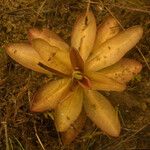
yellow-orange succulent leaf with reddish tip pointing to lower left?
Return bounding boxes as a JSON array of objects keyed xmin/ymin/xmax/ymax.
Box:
[{"xmin": 30, "ymin": 78, "xmax": 70, "ymax": 112}]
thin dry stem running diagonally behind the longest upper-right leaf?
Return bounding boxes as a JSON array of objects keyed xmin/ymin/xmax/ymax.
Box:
[{"xmin": 100, "ymin": 1, "xmax": 150, "ymax": 70}]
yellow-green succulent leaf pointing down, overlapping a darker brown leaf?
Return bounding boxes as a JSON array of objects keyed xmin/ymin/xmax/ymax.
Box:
[{"xmin": 54, "ymin": 87, "xmax": 83, "ymax": 132}]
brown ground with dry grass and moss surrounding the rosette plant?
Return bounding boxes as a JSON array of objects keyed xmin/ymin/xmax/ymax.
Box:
[{"xmin": 0, "ymin": 0, "xmax": 150, "ymax": 150}]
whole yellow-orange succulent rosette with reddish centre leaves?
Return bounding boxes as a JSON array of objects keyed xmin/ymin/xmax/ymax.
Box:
[{"xmin": 6, "ymin": 11, "xmax": 143, "ymax": 142}]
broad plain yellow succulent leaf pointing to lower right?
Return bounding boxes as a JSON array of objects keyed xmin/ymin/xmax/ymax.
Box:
[{"xmin": 84, "ymin": 90, "xmax": 120, "ymax": 137}]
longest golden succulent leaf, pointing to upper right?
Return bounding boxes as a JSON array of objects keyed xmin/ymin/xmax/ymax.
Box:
[{"xmin": 86, "ymin": 26, "xmax": 143, "ymax": 71}]
